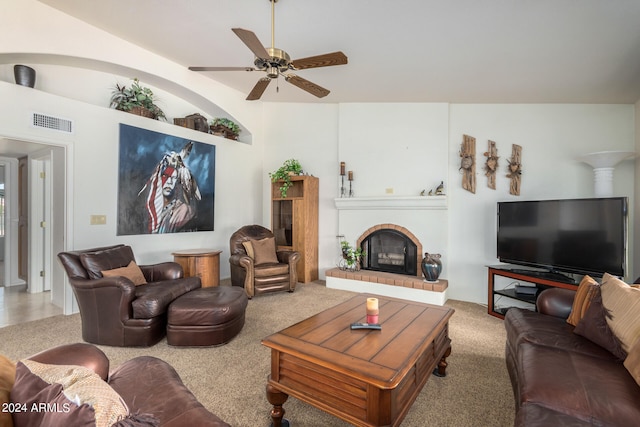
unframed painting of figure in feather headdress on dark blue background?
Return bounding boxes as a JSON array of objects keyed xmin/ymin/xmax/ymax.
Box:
[{"xmin": 118, "ymin": 124, "xmax": 216, "ymax": 236}]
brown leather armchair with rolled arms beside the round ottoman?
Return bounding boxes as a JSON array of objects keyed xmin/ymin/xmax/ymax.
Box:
[{"xmin": 58, "ymin": 245, "xmax": 201, "ymax": 347}]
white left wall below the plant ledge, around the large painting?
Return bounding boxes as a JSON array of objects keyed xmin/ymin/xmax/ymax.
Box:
[{"xmin": 0, "ymin": 82, "xmax": 263, "ymax": 314}]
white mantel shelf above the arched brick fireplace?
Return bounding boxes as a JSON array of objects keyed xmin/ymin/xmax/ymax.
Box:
[{"xmin": 334, "ymin": 196, "xmax": 447, "ymax": 210}]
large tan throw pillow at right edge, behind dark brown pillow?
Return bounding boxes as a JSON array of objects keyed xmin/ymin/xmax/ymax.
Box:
[{"xmin": 600, "ymin": 274, "xmax": 640, "ymax": 353}]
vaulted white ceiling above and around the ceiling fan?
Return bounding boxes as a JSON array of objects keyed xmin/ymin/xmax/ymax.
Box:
[{"xmin": 40, "ymin": 0, "xmax": 640, "ymax": 103}]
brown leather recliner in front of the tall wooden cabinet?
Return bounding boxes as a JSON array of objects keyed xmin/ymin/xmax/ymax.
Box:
[{"xmin": 229, "ymin": 225, "xmax": 300, "ymax": 298}]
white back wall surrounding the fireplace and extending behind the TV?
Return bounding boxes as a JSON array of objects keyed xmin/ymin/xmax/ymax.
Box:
[{"xmin": 265, "ymin": 104, "xmax": 634, "ymax": 303}]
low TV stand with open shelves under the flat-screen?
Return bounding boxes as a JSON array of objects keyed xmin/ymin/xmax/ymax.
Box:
[{"xmin": 487, "ymin": 265, "xmax": 578, "ymax": 319}]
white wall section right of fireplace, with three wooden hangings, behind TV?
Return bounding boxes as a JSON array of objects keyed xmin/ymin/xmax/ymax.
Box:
[{"xmin": 449, "ymin": 104, "xmax": 634, "ymax": 302}]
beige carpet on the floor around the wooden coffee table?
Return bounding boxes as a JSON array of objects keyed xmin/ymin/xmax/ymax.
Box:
[{"xmin": 0, "ymin": 283, "xmax": 514, "ymax": 427}]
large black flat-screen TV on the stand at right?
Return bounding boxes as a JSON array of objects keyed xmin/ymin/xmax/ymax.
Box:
[{"xmin": 497, "ymin": 197, "xmax": 628, "ymax": 277}]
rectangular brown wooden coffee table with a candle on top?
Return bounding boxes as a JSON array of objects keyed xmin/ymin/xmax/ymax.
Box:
[{"xmin": 262, "ymin": 294, "xmax": 454, "ymax": 427}]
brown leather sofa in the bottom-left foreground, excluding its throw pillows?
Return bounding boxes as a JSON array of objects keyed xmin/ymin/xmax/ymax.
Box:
[{"xmin": 12, "ymin": 343, "xmax": 229, "ymax": 427}]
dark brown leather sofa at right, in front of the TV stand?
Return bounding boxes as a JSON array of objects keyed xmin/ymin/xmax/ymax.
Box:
[{"xmin": 504, "ymin": 288, "xmax": 640, "ymax": 427}]
